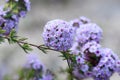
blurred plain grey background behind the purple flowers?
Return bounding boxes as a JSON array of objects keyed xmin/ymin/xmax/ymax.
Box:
[{"xmin": 0, "ymin": 0, "xmax": 120, "ymax": 80}]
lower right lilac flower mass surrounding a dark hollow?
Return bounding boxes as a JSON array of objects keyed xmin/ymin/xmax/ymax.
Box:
[{"xmin": 73, "ymin": 41, "xmax": 120, "ymax": 80}]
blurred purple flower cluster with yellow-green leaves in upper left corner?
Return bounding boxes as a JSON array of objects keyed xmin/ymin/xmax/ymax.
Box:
[{"xmin": 0, "ymin": 0, "xmax": 30, "ymax": 36}]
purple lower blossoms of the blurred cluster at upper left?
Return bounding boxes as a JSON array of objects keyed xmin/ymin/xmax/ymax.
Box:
[{"xmin": 0, "ymin": 7, "xmax": 19, "ymax": 35}]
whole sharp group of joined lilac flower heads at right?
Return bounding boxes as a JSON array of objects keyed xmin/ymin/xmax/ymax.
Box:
[{"xmin": 43, "ymin": 17, "xmax": 120, "ymax": 80}]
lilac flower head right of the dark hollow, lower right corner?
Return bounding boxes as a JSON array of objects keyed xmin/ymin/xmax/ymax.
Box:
[{"xmin": 93, "ymin": 48, "xmax": 118, "ymax": 80}]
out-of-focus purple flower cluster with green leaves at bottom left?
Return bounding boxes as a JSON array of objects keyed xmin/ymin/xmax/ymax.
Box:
[{"xmin": 18, "ymin": 53, "xmax": 53, "ymax": 80}]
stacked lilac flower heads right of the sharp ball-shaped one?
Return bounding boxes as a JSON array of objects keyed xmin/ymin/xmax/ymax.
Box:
[{"xmin": 70, "ymin": 17, "xmax": 120, "ymax": 80}]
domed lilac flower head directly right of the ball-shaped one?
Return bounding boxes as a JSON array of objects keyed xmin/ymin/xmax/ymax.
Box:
[{"xmin": 75, "ymin": 23, "xmax": 102, "ymax": 45}]
